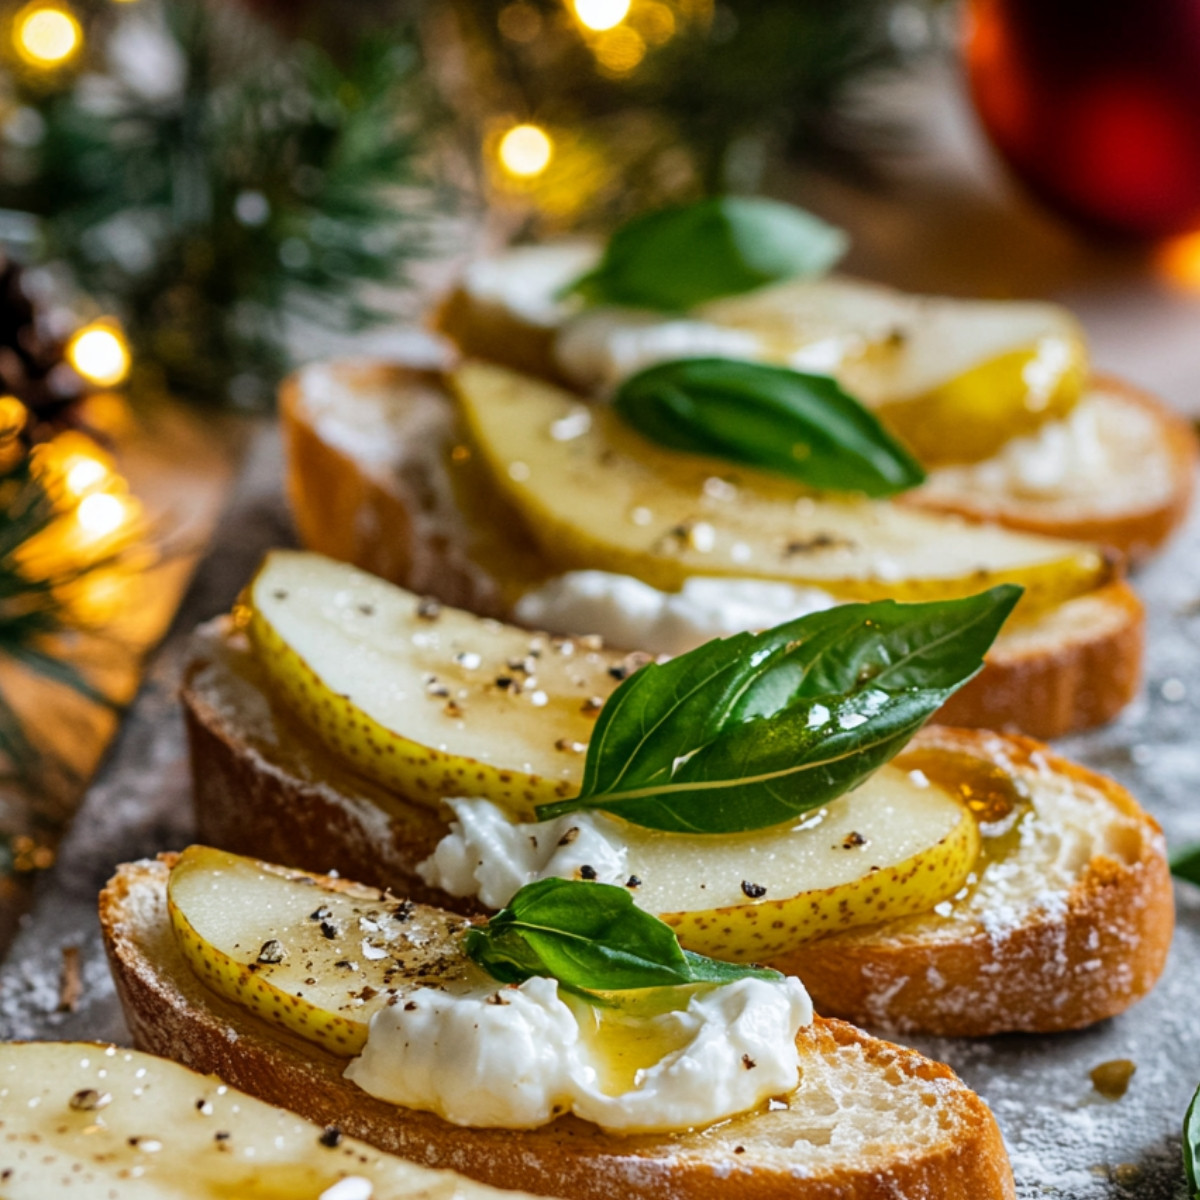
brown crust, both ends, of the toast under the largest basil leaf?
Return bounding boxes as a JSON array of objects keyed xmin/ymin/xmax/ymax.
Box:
[{"xmin": 182, "ymin": 633, "xmax": 1174, "ymax": 1036}]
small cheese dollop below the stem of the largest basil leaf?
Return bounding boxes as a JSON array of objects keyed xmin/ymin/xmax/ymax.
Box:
[{"xmin": 416, "ymin": 798, "xmax": 629, "ymax": 908}]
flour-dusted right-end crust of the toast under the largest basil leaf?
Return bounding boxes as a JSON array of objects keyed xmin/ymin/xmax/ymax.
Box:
[{"xmin": 774, "ymin": 727, "xmax": 1175, "ymax": 1037}]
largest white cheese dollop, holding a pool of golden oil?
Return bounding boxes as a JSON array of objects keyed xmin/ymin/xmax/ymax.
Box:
[{"xmin": 346, "ymin": 972, "xmax": 812, "ymax": 1133}]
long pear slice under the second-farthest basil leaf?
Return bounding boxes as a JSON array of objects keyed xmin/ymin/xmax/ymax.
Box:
[{"xmin": 454, "ymin": 364, "xmax": 1110, "ymax": 613}]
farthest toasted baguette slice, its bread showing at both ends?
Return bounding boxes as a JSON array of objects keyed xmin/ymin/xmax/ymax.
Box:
[{"xmin": 432, "ymin": 262, "xmax": 1198, "ymax": 563}]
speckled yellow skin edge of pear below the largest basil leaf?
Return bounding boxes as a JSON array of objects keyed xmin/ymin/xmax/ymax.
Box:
[{"xmin": 659, "ymin": 808, "xmax": 980, "ymax": 962}]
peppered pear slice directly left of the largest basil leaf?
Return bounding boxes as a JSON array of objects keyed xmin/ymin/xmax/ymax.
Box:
[{"xmin": 239, "ymin": 551, "xmax": 620, "ymax": 816}]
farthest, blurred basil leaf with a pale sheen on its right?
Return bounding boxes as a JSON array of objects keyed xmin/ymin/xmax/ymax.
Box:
[{"xmin": 566, "ymin": 196, "xmax": 847, "ymax": 312}]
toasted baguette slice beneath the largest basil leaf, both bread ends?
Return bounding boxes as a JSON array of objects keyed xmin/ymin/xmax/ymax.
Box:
[{"xmin": 184, "ymin": 623, "xmax": 1174, "ymax": 1036}]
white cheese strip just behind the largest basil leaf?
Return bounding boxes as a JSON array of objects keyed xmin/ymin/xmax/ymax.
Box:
[{"xmin": 514, "ymin": 571, "xmax": 838, "ymax": 654}]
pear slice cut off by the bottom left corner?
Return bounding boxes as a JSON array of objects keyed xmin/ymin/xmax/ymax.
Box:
[{"xmin": 0, "ymin": 1042, "xmax": 544, "ymax": 1200}]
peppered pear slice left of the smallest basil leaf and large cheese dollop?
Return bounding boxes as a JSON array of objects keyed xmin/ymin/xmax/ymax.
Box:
[{"xmin": 167, "ymin": 846, "xmax": 478, "ymax": 1057}]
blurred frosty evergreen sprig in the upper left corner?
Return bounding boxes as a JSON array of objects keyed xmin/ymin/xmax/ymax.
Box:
[{"xmin": 0, "ymin": 0, "xmax": 431, "ymax": 407}]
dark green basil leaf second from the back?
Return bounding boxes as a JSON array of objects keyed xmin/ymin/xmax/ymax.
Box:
[{"xmin": 613, "ymin": 359, "xmax": 925, "ymax": 496}]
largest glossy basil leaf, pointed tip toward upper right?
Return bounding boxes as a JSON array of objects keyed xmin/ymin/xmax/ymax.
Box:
[{"xmin": 538, "ymin": 584, "xmax": 1021, "ymax": 834}]
